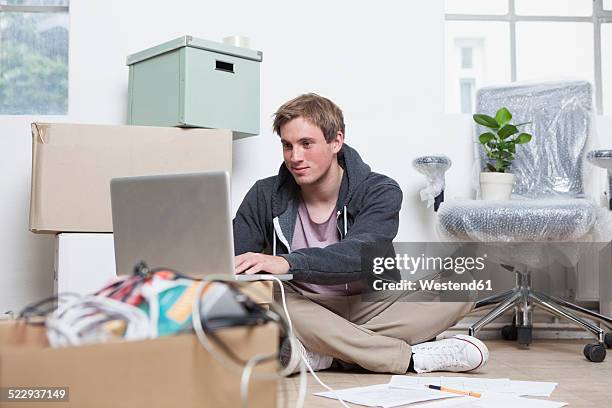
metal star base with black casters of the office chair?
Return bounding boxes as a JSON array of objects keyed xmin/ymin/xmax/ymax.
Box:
[{"xmin": 469, "ymin": 265, "xmax": 612, "ymax": 362}]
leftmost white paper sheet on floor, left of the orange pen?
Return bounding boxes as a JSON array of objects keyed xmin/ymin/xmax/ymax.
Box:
[{"xmin": 315, "ymin": 384, "xmax": 461, "ymax": 408}]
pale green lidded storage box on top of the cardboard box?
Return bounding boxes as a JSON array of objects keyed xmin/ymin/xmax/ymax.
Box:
[{"xmin": 127, "ymin": 35, "xmax": 263, "ymax": 139}]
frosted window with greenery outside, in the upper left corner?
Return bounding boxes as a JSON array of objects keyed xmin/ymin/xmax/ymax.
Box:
[{"xmin": 0, "ymin": 0, "xmax": 68, "ymax": 115}]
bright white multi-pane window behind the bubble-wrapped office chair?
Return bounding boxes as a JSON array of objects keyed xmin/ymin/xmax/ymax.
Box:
[{"xmin": 445, "ymin": 0, "xmax": 612, "ymax": 114}]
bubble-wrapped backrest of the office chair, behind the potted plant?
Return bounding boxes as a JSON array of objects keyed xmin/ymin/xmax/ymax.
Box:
[{"xmin": 475, "ymin": 81, "xmax": 593, "ymax": 198}]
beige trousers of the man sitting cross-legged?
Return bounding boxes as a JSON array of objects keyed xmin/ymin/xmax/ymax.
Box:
[{"xmin": 274, "ymin": 284, "xmax": 474, "ymax": 374}]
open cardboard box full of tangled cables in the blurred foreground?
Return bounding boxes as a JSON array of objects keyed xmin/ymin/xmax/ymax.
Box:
[{"xmin": 0, "ymin": 266, "xmax": 285, "ymax": 408}]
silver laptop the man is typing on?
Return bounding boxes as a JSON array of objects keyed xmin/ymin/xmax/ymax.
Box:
[{"xmin": 111, "ymin": 172, "xmax": 293, "ymax": 281}]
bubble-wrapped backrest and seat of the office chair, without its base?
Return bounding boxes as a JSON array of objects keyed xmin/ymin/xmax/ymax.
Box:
[{"xmin": 437, "ymin": 81, "xmax": 612, "ymax": 267}]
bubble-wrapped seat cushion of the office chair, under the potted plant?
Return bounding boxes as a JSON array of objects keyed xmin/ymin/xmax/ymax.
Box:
[{"xmin": 438, "ymin": 199, "xmax": 612, "ymax": 269}]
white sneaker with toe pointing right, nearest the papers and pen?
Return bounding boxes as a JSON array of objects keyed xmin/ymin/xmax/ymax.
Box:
[{"xmin": 412, "ymin": 334, "xmax": 489, "ymax": 373}]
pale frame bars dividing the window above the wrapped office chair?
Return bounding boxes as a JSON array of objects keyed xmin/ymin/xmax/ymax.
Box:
[{"xmin": 445, "ymin": 0, "xmax": 612, "ymax": 115}]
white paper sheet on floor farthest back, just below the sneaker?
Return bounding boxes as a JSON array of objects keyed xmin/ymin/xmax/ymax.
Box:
[{"xmin": 389, "ymin": 375, "xmax": 557, "ymax": 397}]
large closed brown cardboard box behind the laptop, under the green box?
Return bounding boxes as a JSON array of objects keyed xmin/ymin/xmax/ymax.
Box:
[{"xmin": 30, "ymin": 123, "xmax": 232, "ymax": 232}]
